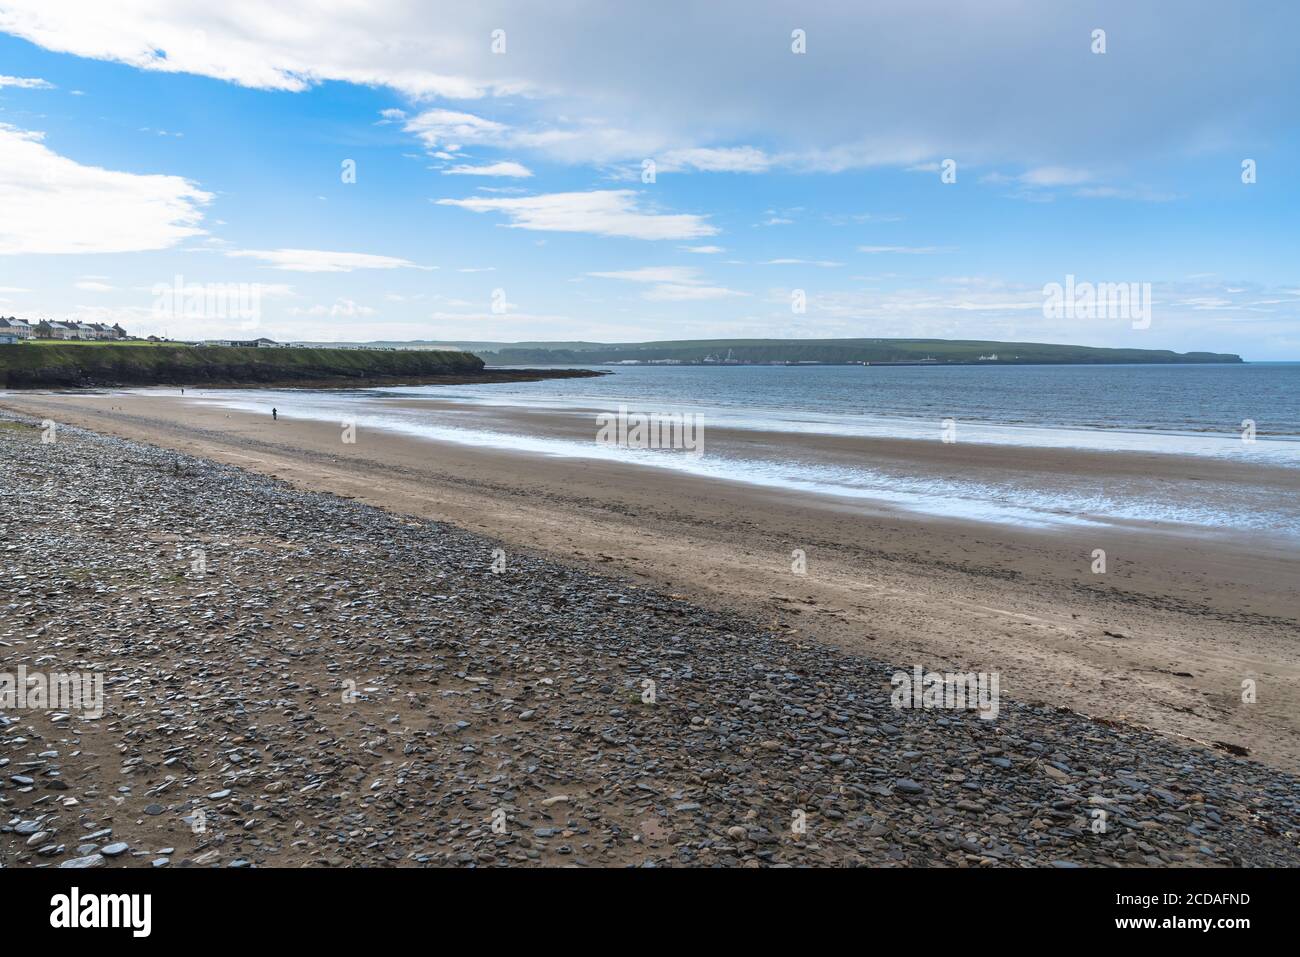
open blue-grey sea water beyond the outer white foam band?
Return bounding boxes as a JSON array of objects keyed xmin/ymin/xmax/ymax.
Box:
[{"xmin": 449, "ymin": 363, "xmax": 1300, "ymax": 438}]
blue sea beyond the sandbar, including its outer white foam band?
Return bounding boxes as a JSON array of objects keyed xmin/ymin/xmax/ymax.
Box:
[{"xmin": 386, "ymin": 363, "xmax": 1300, "ymax": 467}]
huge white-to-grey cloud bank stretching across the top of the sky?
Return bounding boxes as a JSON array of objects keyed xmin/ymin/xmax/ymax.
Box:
[{"xmin": 0, "ymin": 0, "xmax": 1297, "ymax": 172}]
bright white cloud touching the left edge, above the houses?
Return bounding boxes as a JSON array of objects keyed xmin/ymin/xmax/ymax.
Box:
[{"xmin": 0, "ymin": 124, "xmax": 212, "ymax": 255}]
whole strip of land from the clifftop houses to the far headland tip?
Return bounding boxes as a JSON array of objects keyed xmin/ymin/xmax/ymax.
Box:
[{"xmin": 0, "ymin": 327, "xmax": 1242, "ymax": 389}]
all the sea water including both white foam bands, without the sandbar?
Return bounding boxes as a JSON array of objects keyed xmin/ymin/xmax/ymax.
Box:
[{"xmin": 172, "ymin": 363, "xmax": 1300, "ymax": 540}]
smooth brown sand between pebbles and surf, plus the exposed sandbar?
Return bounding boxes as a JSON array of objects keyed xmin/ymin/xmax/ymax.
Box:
[{"xmin": 10, "ymin": 391, "xmax": 1300, "ymax": 771}]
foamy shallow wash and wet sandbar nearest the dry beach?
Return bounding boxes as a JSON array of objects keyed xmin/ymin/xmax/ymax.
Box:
[{"xmin": 178, "ymin": 390, "xmax": 1300, "ymax": 538}]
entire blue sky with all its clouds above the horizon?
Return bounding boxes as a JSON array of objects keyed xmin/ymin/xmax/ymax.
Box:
[{"xmin": 0, "ymin": 0, "xmax": 1300, "ymax": 360}]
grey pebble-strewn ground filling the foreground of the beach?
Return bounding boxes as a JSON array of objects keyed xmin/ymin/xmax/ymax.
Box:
[{"xmin": 0, "ymin": 416, "xmax": 1300, "ymax": 869}]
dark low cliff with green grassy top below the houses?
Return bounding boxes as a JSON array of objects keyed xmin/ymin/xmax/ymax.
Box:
[{"xmin": 0, "ymin": 343, "xmax": 484, "ymax": 389}]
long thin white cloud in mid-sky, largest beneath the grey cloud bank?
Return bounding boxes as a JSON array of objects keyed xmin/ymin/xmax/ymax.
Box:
[{"xmin": 437, "ymin": 190, "xmax": 718, "ymax": 239}]
